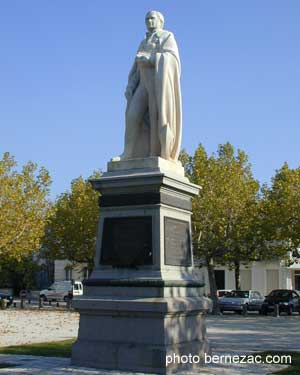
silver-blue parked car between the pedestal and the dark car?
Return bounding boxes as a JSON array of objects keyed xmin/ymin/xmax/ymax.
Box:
[{"xmin": 219, "ymin": 290, "xmax": 264, "ymax": 314}]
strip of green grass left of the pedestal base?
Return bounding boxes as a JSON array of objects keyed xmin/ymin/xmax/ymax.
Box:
[{"xmin": 0, "ymin": 339, "xmax": 75, "ymax": 358}]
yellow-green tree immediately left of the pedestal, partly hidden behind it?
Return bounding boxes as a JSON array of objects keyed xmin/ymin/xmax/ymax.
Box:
[{"xmin": 44, "ymin": 173, "xmax": 100, "ymax": 271}]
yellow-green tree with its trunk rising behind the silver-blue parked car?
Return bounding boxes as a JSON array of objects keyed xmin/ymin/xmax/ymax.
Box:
[{"xmin": 211, "ymin": 143, "xmax": 263, "ymax": 290}]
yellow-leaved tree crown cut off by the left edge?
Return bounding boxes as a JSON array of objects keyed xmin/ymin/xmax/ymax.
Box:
[{"xmin": 0, "ymin": 152, "xmax": 51, "ymax": 261}]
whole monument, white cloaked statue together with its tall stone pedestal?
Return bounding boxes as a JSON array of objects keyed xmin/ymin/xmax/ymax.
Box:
[{"xmin": 72, "ymin": 11, "xmax": 210, "ymax": 374}]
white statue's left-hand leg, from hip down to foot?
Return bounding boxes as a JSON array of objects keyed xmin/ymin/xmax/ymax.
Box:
[{"xmin": 122, "ymin": 84, "xmax": 148, "ymax": 159}]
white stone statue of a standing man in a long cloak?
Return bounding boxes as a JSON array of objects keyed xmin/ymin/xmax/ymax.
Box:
[{"xmin": 121, "ymin": 11, "xmax": 181, "ymax": 161}]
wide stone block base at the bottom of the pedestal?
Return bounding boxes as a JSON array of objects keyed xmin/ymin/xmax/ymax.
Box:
[{"xmin": 72, "ymin": 297, "xmax": 210, "ymax": 374}]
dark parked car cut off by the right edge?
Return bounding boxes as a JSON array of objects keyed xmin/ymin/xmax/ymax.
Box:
[{"xmin": 261, "ymin": 289, "xmax": 300, "ymax": 315}]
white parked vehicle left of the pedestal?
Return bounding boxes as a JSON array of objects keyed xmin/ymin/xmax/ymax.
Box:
[{"xmin": 40, "ymin": 280, "xmax": 83, "ymax": 302}]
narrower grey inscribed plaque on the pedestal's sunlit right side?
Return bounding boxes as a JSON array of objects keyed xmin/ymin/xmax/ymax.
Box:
[{"xmin": 164, "ymin": 217, "xmax": 192, "ymax": 266}]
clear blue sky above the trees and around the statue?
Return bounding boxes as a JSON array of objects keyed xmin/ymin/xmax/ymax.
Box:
[{"xmin": 0, "ymin": 0, "xmax": 300, "ymax": 197}]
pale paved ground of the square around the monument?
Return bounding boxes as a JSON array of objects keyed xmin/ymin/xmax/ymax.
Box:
[{"xmin": 0, "ymin": 311, "xmax": 300, "ymax": 375}]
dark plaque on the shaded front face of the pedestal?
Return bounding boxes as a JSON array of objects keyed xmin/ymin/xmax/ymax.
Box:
[{"xmin": 100, "ymin": 216, "xmax": 152, "ymax": 268}]
